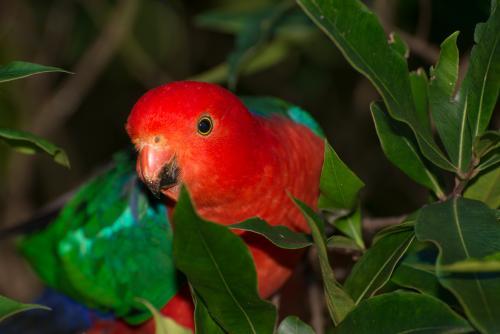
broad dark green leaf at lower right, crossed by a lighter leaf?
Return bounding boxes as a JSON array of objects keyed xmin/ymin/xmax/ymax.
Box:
[{"xmin": 416, "ymin": 198, "xmax": 500, "ymax": 333}]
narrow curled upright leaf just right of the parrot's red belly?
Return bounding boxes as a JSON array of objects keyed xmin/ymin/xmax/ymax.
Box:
[{"xmin": 294, "ymin": 198, "xmax": 354, "ymax": 325}]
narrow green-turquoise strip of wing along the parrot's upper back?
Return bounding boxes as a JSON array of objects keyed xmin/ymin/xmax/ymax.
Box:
[{"xmin": 241, "ymin": 96, "xmax": 325, "ymax": 138}]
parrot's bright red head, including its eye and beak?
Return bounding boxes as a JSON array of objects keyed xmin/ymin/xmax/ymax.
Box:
[{"xmin": 126, "ymin": 81, "xmax": 259, "ymax": 201}]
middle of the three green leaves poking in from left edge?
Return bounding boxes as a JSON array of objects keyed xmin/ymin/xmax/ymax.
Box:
[{"xmin": 0, "ymin": 128, "xmax": 69, "ymax": 168}]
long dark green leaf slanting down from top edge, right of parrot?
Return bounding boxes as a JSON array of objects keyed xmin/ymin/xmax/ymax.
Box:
[{"xmin": 298, "ymin": 0, "xmax": 456, "ymax": 171}]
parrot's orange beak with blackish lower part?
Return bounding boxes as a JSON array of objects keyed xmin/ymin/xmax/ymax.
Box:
[{"xmin": 137, "ymin": 145, "xmax": 179, "ymax": 197}]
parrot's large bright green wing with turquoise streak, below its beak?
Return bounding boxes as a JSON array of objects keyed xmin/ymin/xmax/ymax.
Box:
[{"xmin": 21, "ymin": 153, "xmax": 180, "ymax": 324}]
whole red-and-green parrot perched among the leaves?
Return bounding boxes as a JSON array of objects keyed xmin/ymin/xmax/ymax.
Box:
[{"xmin": 14, "ymin": 81, "xmax": 324, "ymax": 333}]
